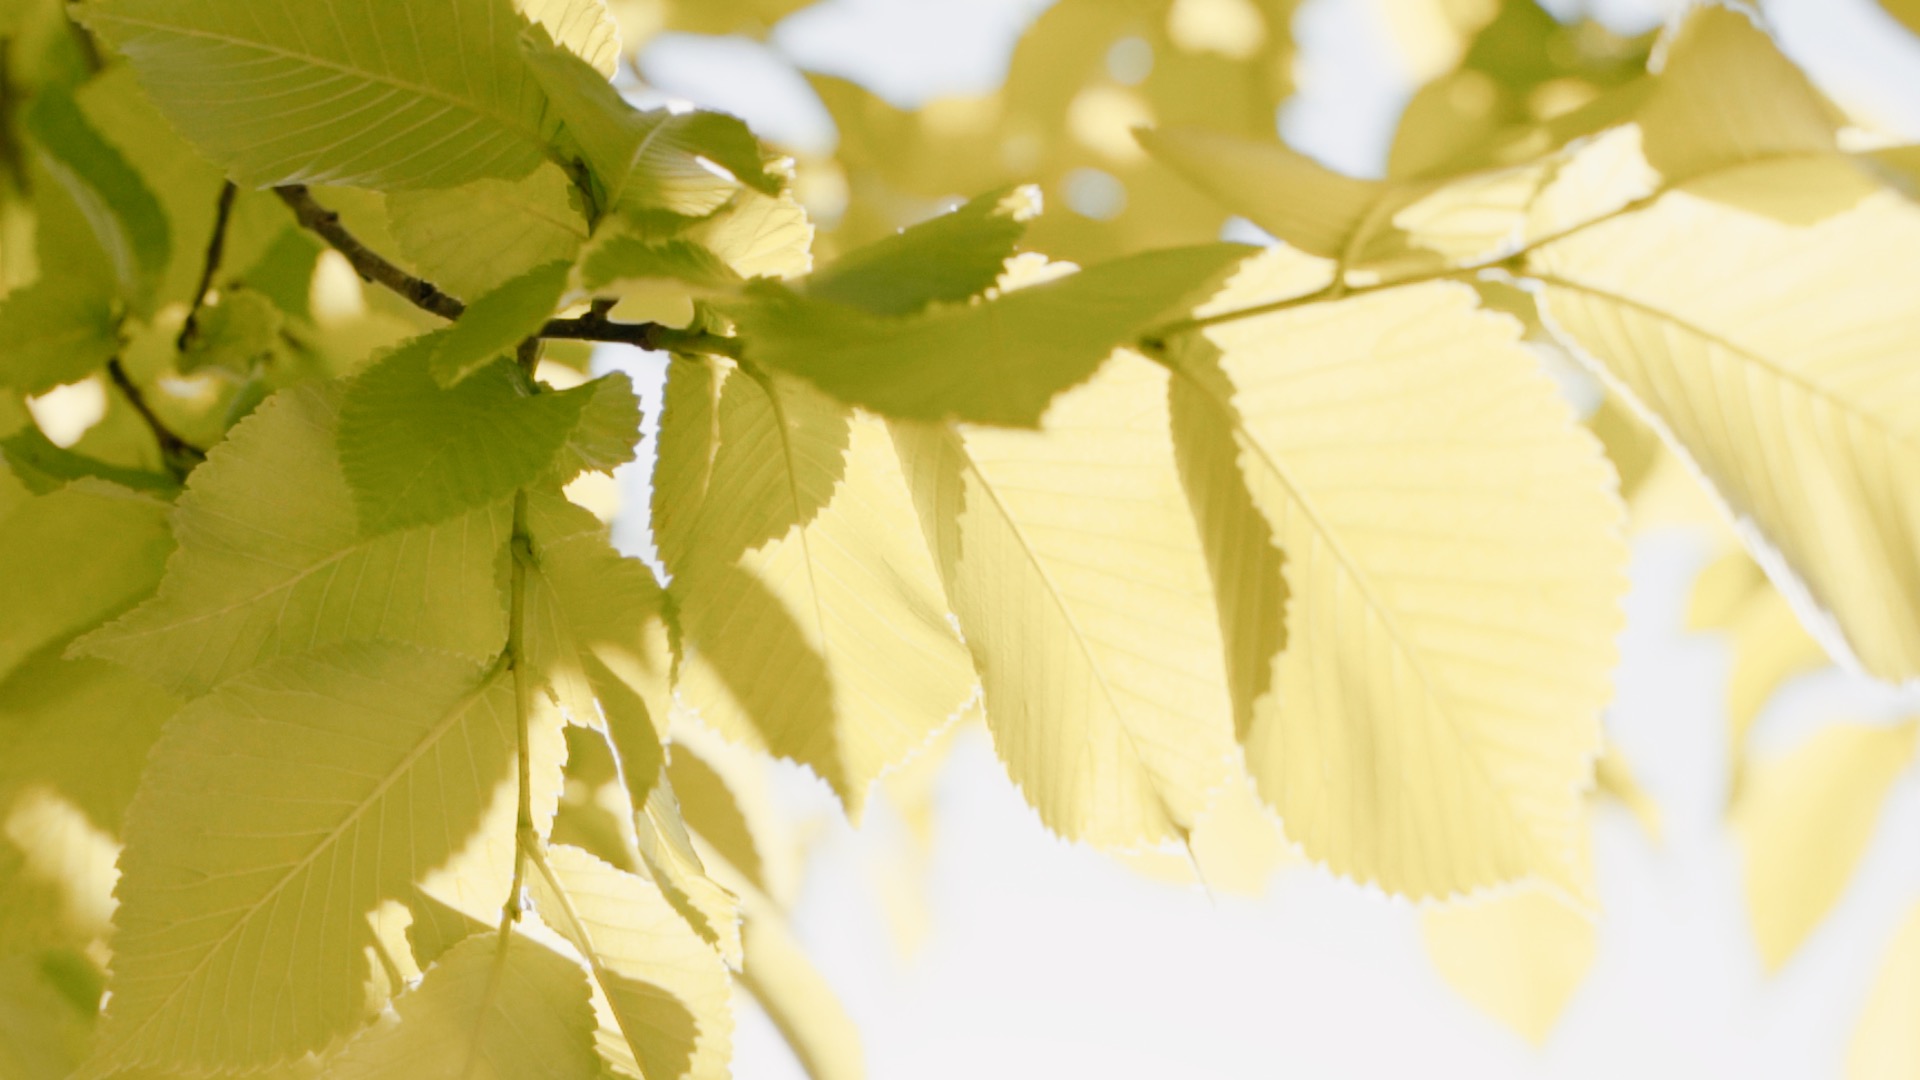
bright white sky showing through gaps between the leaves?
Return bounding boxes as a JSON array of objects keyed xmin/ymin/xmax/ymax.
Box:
[{"xmin": 607, "ymin": 0, "xmax": 1920, "ymax": 1080}]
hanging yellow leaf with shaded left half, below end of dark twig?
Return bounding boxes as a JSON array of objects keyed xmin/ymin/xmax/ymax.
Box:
[{"xmin": 655, "ymin": 361, "xmax": 973, "ymax": 813}]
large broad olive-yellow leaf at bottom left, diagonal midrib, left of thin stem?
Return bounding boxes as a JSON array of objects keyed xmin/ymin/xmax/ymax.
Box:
[{"xmin": 100, "ymin": 642, "xmax": 515, "ymax": 1070}]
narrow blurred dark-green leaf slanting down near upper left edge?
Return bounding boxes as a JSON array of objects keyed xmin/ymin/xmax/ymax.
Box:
[{"xmin": 27, "ymin": 92, "xmax": 173, "ymax": 313}]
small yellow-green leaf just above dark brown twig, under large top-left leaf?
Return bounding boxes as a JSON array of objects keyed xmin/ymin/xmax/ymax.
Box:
[{"xmin": 386, "ymin": 163, "xmax": 588, "ymax": 296}]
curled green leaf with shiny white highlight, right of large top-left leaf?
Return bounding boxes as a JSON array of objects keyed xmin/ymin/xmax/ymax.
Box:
[{"xmin": 526, "ymin": 40, "xmax": 781, "ymax": 217}]
